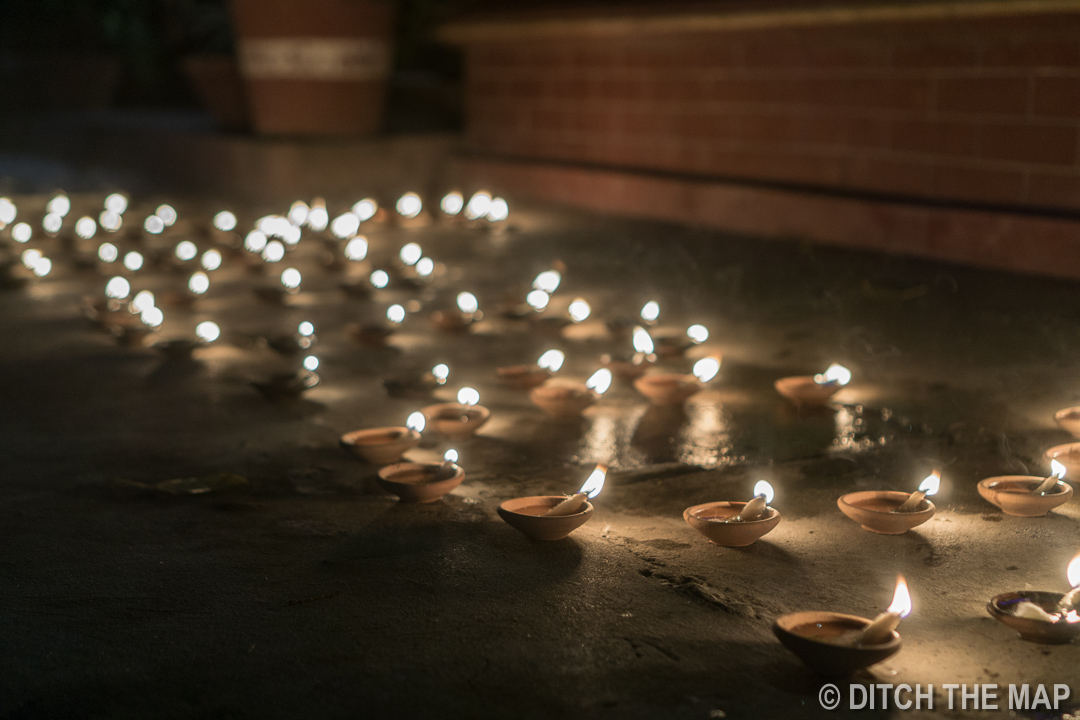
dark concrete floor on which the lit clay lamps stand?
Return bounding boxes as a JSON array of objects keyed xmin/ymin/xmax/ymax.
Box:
[{"xmin": 0, "ymin": 196, "xmax": 1080, "ymax": 720}]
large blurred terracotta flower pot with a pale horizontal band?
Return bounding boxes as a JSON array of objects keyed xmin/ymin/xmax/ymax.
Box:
[{"xmin": 232, "ymin": 0, "xmax": 394, "ymax": 135}]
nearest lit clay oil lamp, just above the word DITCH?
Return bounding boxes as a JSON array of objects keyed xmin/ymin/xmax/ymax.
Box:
[{"xmin": 772, "ymin": 576, "xmax": 912, "ymax": 677}]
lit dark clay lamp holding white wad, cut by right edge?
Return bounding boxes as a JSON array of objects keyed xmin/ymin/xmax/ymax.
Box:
[{"xmin": 986, "ymin": 556, "xmax": 1080, "ymax": 644}]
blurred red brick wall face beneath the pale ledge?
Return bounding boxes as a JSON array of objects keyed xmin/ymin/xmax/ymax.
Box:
[{"xmin": 465, "ymin": 12, "xmax": 1080, "ymax": 210}]
